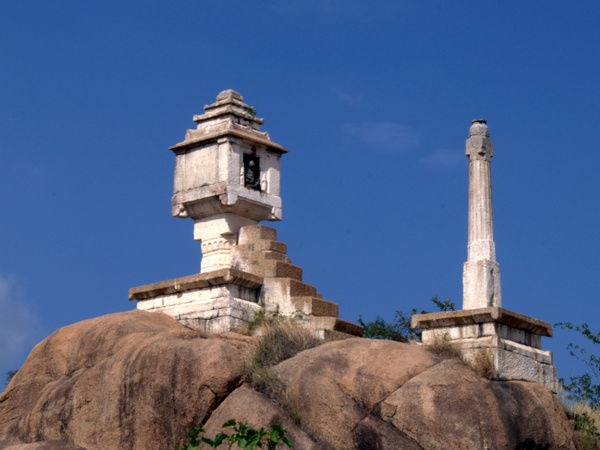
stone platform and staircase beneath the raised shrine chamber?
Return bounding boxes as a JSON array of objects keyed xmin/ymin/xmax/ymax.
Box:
[{"xmin": 129, "ymin": 225, "xmax": 363, "ymax": 338}]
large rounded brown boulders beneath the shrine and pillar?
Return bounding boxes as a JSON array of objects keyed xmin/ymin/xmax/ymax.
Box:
[{"xmin": 0, "ymin": 311, "xmax": 574, "ymax": 449}]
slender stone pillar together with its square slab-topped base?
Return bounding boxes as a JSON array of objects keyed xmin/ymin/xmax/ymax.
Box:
[{"xmin": 412, "ymin": 119, "xmax": 557, "ymax": 392}]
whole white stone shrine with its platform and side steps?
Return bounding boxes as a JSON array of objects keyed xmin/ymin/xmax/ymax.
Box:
[{"xmin": 129, "ymin": 89, "xmax": 363, "ymax": 336}]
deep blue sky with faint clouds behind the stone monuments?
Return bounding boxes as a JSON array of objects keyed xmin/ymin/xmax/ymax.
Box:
[{"xmin": 0, "ymin": 0, "xmax": 600, "ymax": 384}]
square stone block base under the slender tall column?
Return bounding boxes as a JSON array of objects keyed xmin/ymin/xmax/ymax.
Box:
[{"xmin": 411, "ymin": 307, "xmax": 558, "ymax": 393}]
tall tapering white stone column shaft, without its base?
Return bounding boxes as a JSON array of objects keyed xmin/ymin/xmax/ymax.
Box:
[{"xmin": 463, "ymin": 119, "xmax": 502, "ymax": 309}]
